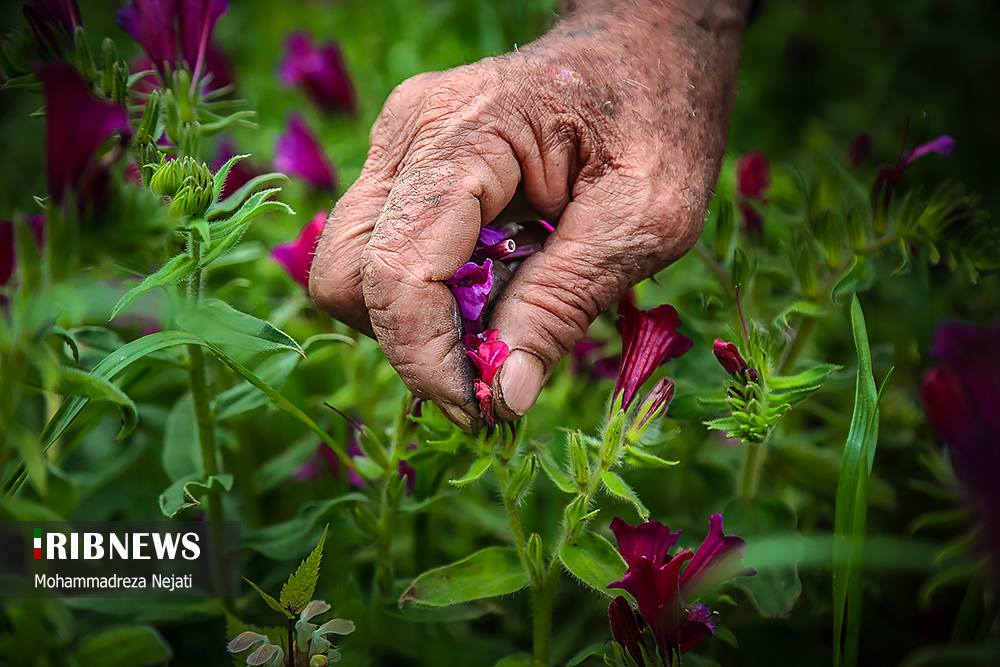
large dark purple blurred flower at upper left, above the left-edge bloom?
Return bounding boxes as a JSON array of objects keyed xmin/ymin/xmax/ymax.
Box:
[{"xmin": 39, "ymin": 62, "xmax": 132, "ymax": 211}]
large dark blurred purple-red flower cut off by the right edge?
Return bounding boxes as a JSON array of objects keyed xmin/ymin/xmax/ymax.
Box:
[{"xmin": 923, "ymin": 324, "xmax": 1000, "ymax": 553}]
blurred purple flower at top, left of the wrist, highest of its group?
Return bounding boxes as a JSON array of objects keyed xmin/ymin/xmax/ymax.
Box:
[{"xmin": 278, "ymin": 32, "xmax": 355, "ymax": 112}]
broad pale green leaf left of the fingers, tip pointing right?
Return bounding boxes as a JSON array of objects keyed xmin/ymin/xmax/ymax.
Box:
[{"xmin": 177, "ymin": 299, "xmax": 305, "ymax": 357}]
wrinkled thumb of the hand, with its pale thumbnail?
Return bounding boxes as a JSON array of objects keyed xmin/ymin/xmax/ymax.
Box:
[{"xmin": 491, "ymin": 172, "xmax": 701, "ymax": 419}]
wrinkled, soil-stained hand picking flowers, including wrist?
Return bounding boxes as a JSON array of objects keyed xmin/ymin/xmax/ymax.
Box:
[{"xmin": 309, "ymin": 0, "xmax": 749, "ymax": 430}]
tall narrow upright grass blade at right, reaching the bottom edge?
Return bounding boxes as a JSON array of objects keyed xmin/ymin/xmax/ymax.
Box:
[{"xmin": 833, "ymin": 296, "xmax": 884, "ymax": 667}]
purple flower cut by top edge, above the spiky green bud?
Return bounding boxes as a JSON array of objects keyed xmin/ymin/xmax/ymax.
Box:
[{"xmin": 116, "ymin": 0, "xmax": 229, "ymax": 87}]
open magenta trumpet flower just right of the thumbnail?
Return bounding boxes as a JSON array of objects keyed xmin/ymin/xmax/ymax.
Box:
[{"xmin": 613, "ymin": 301, "xmax": 694, "ymax": 410}]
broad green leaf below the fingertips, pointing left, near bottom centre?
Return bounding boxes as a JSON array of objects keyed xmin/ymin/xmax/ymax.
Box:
[{"xmin": 399, "ymin": 547, "xmax": 529, "ymax": 607}]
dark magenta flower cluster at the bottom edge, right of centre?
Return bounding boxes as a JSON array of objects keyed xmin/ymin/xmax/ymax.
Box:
[{"xmin": 608, "ymin": 514, "xmax": 756, "ymax": 664}]
